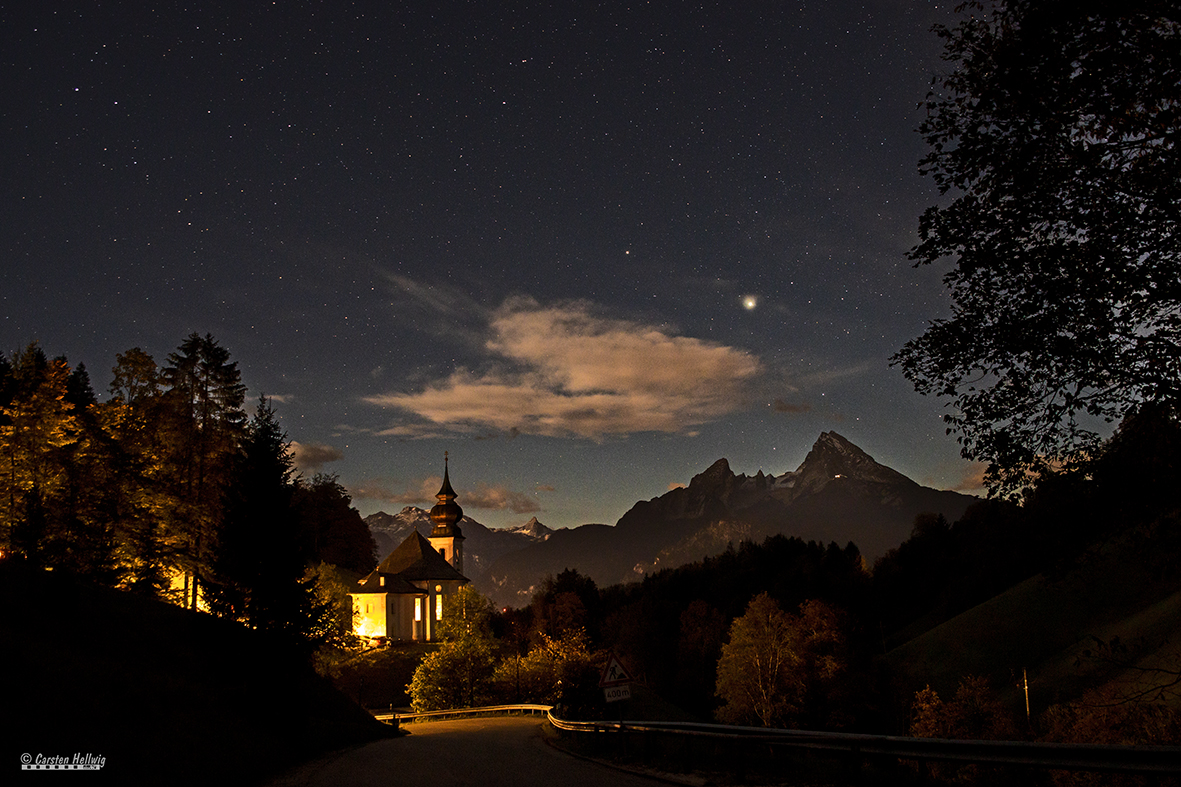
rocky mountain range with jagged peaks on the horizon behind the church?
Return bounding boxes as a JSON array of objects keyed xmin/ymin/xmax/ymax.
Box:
[{"xmin": 365, "ymin": 431, "xmax": 976, "ymax": 606}]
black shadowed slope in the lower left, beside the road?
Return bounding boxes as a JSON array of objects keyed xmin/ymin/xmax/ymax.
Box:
[{"xmin": 0, "ymin": 564, "xmax": 389, "ymax": 785}]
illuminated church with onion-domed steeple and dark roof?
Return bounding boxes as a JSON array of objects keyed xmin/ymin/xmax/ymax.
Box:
[{"xmin": 350, "ymin": 455, "xmax": 468, "ymax": 642}]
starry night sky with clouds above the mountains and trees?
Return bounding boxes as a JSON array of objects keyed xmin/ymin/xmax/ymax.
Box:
[{"xmin": 0, "ymin": 0, "xmax": 977, "ymax": 527}]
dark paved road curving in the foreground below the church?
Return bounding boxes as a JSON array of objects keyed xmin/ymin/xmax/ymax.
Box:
[{"xmin": 270, "ymin": 716, "xmax": 675, "ymax": 787}]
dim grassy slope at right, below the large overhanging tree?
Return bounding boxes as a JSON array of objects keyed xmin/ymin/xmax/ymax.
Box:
[{"xmin": 885, "ymin": 534, "xmax": 1181, "ymax": 715}]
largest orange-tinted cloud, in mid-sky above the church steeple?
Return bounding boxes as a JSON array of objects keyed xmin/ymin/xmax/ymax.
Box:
[{"xmin": 366, "ymin": 299, "xmax": 763, "ymax": 440}]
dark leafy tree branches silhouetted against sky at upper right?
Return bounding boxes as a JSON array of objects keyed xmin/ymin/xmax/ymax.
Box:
[{"xmin": 893, "ymin": 0, "xmax": 1181, "ymax": 493}]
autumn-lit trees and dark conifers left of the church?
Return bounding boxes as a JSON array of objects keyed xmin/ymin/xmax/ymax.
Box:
[{"xmin": 0, "ymin": 333, "xmax": 374, "ymax": 648}]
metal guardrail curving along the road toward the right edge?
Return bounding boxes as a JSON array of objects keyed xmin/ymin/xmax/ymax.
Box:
[{"xmin": 373, "ymin": 704, "xmax": 1181, "ymax": 775}]
